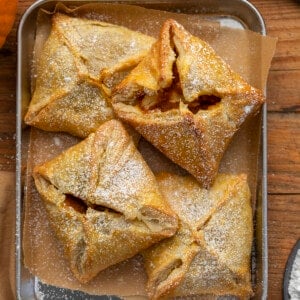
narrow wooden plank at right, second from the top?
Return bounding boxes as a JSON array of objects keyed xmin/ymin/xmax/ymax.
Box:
[{"xmin": 267, "ymin": 69, "xmax": 300, "ymax": 112}]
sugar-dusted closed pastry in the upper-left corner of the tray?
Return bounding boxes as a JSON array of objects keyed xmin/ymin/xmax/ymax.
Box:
[{"xmin": 25, "ymin": 13, "xmax": 154, "ymax": 137}]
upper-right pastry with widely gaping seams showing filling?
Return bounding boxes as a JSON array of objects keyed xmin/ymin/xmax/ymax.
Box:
[{"xmin": 112, "ymin": 20, "xmax": 264, "ymax": 187}]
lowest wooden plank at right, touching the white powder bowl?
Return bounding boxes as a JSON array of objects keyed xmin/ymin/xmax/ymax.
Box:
[{"xmin": 268, "ymin": 195, "xmax": 300, "ymax": 299}]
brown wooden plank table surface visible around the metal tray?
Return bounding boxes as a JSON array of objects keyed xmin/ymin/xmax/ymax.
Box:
[{"xmin": 0, "ymin": 0, "xmax": 300, "ymax": 299}]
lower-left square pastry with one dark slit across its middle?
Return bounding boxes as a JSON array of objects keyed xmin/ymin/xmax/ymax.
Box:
[{"xmin": 33, "ymin": 120, "xmax": 177, "ymax": 283}]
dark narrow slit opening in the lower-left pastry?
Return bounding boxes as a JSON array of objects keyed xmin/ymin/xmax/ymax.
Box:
[{"xmin": 64, "ymin": 194, "xmax": 121, "ymax": 215}]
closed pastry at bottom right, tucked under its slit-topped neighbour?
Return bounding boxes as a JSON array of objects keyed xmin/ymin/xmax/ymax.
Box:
[{"xmin": 143, "ymin": 173, "xmax": 253, "ymax": 299}]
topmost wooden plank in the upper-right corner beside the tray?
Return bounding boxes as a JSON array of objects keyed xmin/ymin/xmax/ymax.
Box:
[{"xmin": 251, "ymin": 0, "xmax": 300, "ymax": 70}]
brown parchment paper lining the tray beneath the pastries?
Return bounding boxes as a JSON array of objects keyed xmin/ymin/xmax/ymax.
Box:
[{"xmin": 23, "ymin": 4, "xmax": 276, "ymax": 297}]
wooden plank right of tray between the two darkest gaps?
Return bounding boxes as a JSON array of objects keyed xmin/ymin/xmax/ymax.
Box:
[{"xmin": 268, "ymin": 113, "xmax": 300, "ymax": 194}]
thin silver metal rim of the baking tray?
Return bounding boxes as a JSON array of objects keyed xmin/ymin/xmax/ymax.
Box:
[{"xmin": 15, "ymin": 0, "xmax": 268, "ymax": 299}]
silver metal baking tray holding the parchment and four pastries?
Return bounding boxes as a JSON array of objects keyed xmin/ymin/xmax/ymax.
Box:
[{"xmin": 16, "ymin": 0, "xmax": 268, "ymax": 300}]
